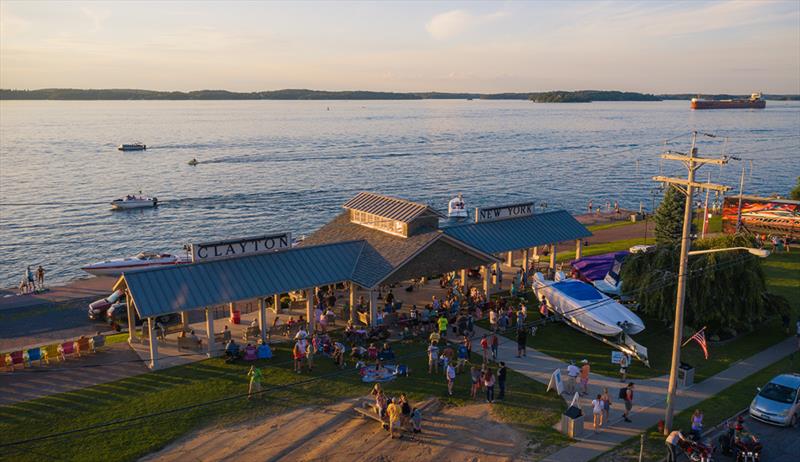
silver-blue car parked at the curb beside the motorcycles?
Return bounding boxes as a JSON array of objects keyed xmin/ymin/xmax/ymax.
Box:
[{"xmin": 750, "ymin": 374, "xmax": 800, "ymax": 426}]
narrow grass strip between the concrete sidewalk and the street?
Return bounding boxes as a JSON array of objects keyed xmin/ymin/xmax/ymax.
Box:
[{"xmin": 594, "ymin": 353, "xmax": 800, "ymax": 462}]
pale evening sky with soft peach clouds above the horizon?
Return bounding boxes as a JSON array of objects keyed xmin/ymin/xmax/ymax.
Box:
[{"xmin": 0, "ymin": 0, "xmax": 800, "ymax": 94}]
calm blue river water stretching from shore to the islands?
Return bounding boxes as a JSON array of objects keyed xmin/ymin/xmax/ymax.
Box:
[{"xmin": 0, "ymin": 101, "xmax": 800, "ymax": 287}]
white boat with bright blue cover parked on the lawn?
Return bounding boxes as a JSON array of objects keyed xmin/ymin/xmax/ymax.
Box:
[{"xmin": 533, "ymin": 271, "xmax": 644, "ymax": 337}]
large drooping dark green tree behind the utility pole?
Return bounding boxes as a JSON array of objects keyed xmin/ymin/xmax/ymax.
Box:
[{"xmin": 620, "ymin": 234, "xmax": 777, "ymax": 332}]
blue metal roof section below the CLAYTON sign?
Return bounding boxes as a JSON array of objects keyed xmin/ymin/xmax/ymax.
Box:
[{"xmin": 117, "ymin": 241, "xmax": 366, "ymax": 318}]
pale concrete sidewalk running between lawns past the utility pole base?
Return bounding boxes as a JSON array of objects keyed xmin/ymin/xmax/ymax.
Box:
[{"xmin": 466, "ymin": 327, "xmax": 797, "ymax": 462}]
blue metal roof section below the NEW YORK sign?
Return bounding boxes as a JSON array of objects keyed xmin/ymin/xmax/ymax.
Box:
[{"xmin": 442, "ymin": 210, "xmax": 592, "ymax": 254}]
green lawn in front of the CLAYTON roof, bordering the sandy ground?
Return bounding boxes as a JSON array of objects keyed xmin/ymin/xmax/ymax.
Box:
[{"xmin": 0, "ymin": 334, "xmax": 567, "ymax": 461}]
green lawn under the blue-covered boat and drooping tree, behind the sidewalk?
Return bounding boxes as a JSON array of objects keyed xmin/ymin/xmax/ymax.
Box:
[{"xmin": 490, "ymin": 253, "xmax": 800, "ymax": 382}]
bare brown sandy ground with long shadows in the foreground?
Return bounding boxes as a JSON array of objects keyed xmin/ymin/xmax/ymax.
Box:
[{"xmin": 142, "ymin": 400, "xmax": 527, "ymax": 462}]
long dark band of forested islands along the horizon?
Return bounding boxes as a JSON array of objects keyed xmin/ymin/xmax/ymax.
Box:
[{"xmin": 0, "ymin": 88, "xmax": 800, "ymax": 103}]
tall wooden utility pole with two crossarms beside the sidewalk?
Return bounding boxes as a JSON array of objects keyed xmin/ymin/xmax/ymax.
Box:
[{"xmin": 653, "ymin": 131, "xmax": 729, "ymax": 435}]
